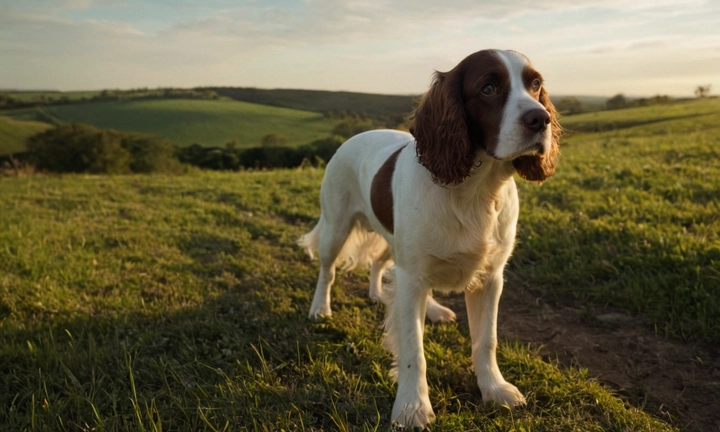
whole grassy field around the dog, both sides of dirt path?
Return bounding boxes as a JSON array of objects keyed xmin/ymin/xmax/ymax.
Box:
[{"xmin": 0, "ymin": 99, "xmax": 720, "ymax": 431}]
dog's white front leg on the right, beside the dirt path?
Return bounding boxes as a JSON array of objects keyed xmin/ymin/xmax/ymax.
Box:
[{"xmin": 465, "ymin": 272, "xmax": 525, "ymax": 407}]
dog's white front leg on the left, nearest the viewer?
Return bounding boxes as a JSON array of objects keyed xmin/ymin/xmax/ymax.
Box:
[{"xmin": 387, "ymin": 267, "xmax": 435, "ymax": 428}]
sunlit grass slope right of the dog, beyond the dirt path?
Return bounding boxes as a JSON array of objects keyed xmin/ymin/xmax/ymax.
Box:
[{"xmin": 511, "ymin": 99, "xmax": 720, "ymax": 343}]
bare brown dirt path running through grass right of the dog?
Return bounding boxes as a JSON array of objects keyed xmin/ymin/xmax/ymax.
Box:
[{"xmin": 438, "ymin": 281, "xmax": 720, "ymax": 432}]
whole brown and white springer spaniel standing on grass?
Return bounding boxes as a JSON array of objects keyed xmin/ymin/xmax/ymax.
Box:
[{"xmin": 300, "ymin": 50, "xmax": 561, "ymax": 427}]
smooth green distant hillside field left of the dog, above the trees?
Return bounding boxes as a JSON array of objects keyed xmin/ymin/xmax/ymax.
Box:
[{"xmin": 3, "ymin": 99, "xmax": 337, "ymax": 147}]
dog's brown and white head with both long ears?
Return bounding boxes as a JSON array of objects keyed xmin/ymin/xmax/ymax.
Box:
[{"xmin": 410, "ymin": 50, "xmax": 562, "ymax": 185}]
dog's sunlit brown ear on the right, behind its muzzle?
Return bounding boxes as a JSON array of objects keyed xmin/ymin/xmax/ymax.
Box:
[{"xmin": 513, "ymin": 88, "xmax": 562, "ymax": 182}]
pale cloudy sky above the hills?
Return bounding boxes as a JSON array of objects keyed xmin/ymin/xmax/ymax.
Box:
[{"xmin": 0, "ymin": 0, "xmax": 720, "ymax": 96}]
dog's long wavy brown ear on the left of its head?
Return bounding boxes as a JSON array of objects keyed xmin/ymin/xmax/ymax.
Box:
[{"xmin": 410, "ymin": 68, "xmax": 475, "ymax": 185}]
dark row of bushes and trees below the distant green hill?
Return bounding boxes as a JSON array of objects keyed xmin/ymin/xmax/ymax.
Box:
[{"xmin": 11, "ymin": 123, "xmax": 356, "ymax": 174}]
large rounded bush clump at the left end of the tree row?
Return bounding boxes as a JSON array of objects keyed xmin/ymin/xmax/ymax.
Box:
[{"xmin": 27, "ymin": 124, "xmax": 180, "ymax": 174}]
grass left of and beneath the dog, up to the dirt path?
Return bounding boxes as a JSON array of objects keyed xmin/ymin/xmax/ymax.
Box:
[{"xmin": 0, "ymin": 170, "xmax": 671, "ymax": 431}]
